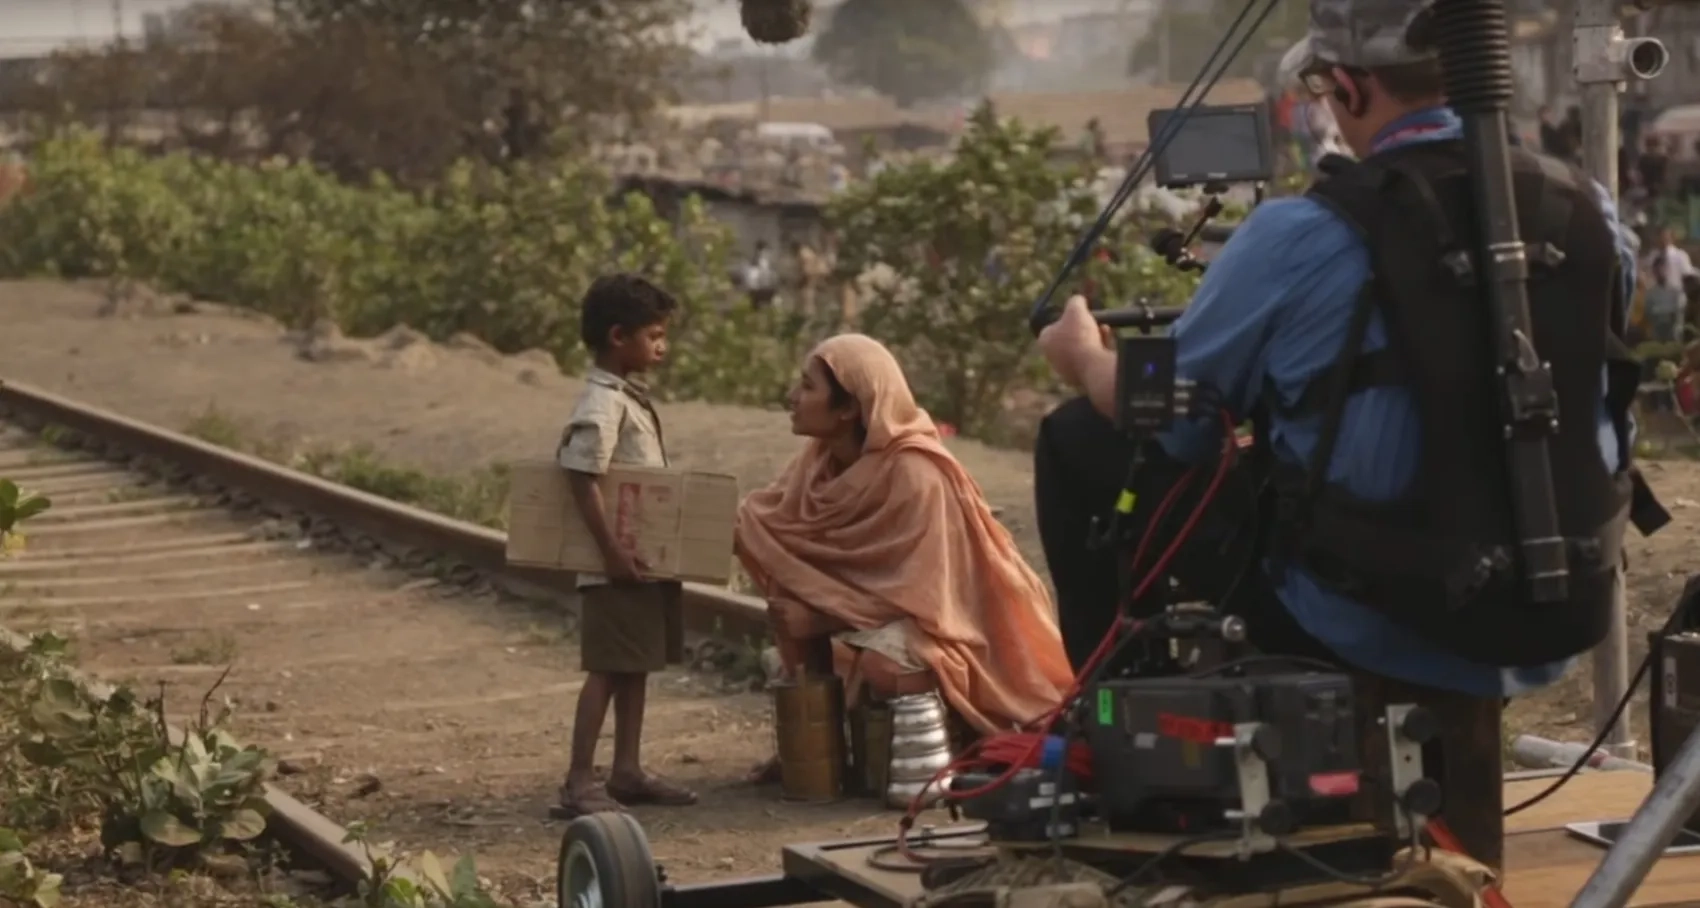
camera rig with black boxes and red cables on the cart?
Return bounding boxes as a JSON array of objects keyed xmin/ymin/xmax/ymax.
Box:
[{"xmin": 947, "ymin": 306, "xmax": 1442, "ymax": 891}]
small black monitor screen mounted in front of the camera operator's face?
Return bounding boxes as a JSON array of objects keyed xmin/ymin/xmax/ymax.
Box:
[{"xmin": 1149, "ymin": 105, "xmax": 1273, "ymax": 185}]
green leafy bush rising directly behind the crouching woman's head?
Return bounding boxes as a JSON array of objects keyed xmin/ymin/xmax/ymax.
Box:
[{"xmin": 830, "ymin": 105, "xmax": 1195, "ymax": 440}]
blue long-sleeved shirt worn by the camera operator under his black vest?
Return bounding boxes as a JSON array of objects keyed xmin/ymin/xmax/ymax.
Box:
[{"xmin": 1161, "ymin": 107, "xmax": 1635, "ymax": 697}]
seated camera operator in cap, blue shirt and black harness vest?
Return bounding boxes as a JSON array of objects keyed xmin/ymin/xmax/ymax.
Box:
[{"xmin": 1035, "ymin": 0, "xmax": 1635, "ymax": 864}]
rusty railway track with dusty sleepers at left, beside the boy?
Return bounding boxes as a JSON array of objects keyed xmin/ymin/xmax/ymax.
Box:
[{"xmin": 0, "ymin": 384, "xmax": 891, "ymax": 881}]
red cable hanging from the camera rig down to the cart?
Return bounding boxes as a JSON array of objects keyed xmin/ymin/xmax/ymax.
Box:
[{"xmin": 898, "ymin": 410, "xmax": 1239, "ymax": 862}]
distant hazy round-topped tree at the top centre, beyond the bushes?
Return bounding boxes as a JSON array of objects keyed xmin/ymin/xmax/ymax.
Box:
[{"xmin": 814, "ymin": 0, "xmax": 996, "ymax": 107}]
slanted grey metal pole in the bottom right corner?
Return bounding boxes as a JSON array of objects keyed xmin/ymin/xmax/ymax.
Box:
[{"xmin": 1571, "ymin": 731, "xmax": 1700, "ymax": 908}]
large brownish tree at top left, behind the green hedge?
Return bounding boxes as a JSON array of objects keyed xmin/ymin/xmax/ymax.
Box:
[{"xmin": 13, "ymin": 0, "xmax": 689, "ymax": 184}]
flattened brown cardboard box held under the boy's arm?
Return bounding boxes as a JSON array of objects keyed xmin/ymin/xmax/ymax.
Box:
[{"xmin": 508, "ymin": 461, "xmax": 738, "ymax": 583}]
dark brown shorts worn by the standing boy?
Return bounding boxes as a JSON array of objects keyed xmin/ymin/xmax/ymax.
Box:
[{"xmin": 578, "ymin": 582, "xmax": 685, "ymax": 675}]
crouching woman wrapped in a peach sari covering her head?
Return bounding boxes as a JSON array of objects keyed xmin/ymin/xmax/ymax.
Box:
[{"xmin": 736, "ymin": 335, "xmax": 1071, "ymax": 782}]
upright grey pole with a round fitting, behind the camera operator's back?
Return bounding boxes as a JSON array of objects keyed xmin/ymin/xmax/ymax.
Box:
[{"xmin": 1573, "ymin": 0, "xmax": 1669, "ymax": 758}]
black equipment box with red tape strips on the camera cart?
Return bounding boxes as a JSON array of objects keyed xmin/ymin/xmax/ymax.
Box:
[{"xmin": 1086, "ymin": 673, "xmax": 1363, "ymax": 833}]
